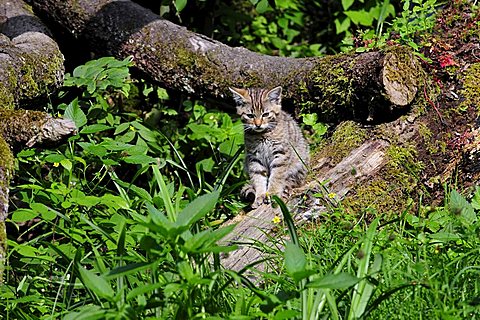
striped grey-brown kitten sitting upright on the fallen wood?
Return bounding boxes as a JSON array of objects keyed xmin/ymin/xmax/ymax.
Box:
[{"xmin": 229, "ymin": 87, "xmax": 309, "ymax": 208}]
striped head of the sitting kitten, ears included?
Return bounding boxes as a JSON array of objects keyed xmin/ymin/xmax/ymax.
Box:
[{"xmin": 229, "ymin": 87, "xmax": 282, "ymax": 133}]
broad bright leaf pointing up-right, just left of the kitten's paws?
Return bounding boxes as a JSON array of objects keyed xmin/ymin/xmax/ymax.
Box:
[{"xmin": 176, "ymin": 190, "xmax": 220, "ymax": 227}]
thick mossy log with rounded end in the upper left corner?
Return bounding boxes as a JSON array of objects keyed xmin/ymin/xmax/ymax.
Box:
[{"xmin": 0, "ymin": 0, "xmax": 64, "ymax": 109}]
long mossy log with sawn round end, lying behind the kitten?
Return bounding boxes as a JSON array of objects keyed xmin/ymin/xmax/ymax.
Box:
[{"xmin": 32, "ymin": 0, "xmax": 419, "ymax": 122}]
